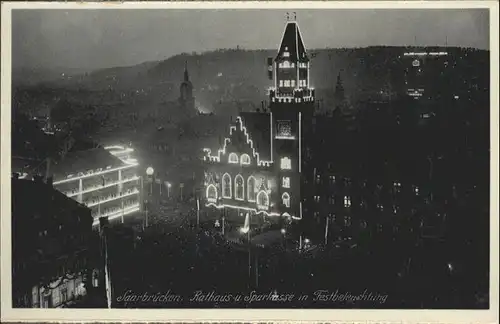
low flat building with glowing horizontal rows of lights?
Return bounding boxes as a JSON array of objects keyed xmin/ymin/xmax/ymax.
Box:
[{"xmin": 53, "ymin": 146, "xmax": 141, "ymax": 226}]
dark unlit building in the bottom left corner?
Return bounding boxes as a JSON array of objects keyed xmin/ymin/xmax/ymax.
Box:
[{"xmin": 12, "ymin": 177, "xmax": 99, "ymax": 308}]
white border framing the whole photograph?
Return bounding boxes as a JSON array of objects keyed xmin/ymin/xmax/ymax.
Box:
[{"xmin": 0, "ymin": 1, "xmax": 499, "ymax": 323}]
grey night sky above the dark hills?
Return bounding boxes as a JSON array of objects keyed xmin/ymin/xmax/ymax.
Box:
[{"xmin": 12, "ymin": 9, "xmax": 489, "ymax": 69}]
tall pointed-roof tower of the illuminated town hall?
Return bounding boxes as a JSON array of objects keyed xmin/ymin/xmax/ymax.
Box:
[{"xmin": 268, "ymin": 17, "xmax": 315, "ymax": 219}]
